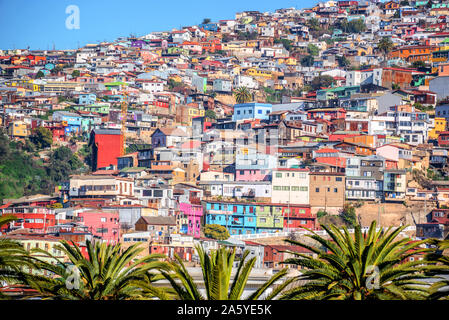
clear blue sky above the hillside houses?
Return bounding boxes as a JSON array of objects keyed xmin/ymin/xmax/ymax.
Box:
[{"xmin": 0, "ymin": 0, "xmax": 318, "ymax": 50}]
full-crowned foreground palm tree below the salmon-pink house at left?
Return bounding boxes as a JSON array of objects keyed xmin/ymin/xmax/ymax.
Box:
[{"xmin": 29, "ymin": 241, "xmax": 169, "ymax": 300}]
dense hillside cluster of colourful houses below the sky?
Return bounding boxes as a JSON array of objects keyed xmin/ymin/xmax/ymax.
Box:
[{"xmin": 0, "ymin": 0, "xmax": 449, "ymax": 267}]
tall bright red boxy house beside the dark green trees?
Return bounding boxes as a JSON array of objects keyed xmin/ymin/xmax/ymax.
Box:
[{"xmin": 89, "ymin": 129, "xmax": 123, "ymax": 171}]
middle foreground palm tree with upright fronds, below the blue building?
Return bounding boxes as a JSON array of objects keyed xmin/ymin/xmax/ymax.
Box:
[{"xmin": 161, "ymin": 246, "xmax": 292, "ymax": 300}]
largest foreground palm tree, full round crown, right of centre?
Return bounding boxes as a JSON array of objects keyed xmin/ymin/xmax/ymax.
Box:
[{"xmin": 281, "ymin": 221, "xmax": 429, "ymax": 300}]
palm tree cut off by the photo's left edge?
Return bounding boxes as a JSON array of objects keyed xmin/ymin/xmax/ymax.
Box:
[{"xmin": 0, "ymin": 215, "xmax": 40, "ymax": 298}]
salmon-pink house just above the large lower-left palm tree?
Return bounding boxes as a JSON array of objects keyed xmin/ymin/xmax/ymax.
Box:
[{"xmin": 78, "ymin": 210, "xmax": 120, "ymax": 243}]
